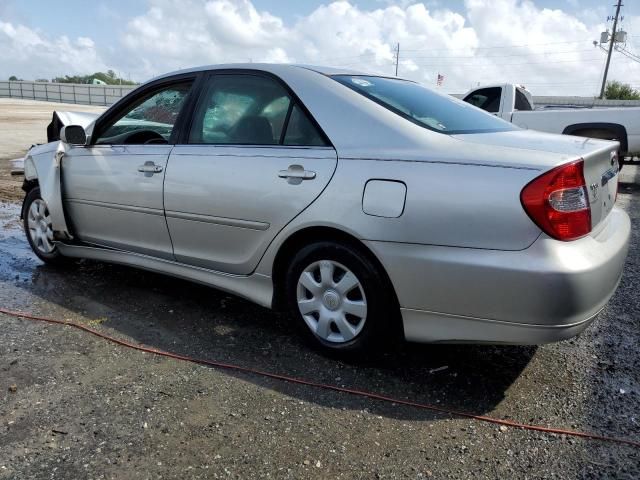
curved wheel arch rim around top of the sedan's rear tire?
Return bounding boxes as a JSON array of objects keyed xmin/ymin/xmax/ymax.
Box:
[{"xmin": 271, "ymin": 226, "xmax": 400, "ymax": 315}]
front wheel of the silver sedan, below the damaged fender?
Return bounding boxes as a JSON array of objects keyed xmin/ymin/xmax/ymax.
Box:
[{"xmin": 22, "ymin": 187, "xmax": 68, "ymax": 265}]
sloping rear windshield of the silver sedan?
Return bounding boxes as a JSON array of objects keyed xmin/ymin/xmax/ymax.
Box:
[{"xmin": 332, "ymin": 75, "xmax": 517, "ymax": 134}]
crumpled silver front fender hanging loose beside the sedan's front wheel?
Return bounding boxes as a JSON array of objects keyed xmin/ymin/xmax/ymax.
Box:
[{"xmin": 23, "ymin": 141, "xmax": 73, "ymax": 240}]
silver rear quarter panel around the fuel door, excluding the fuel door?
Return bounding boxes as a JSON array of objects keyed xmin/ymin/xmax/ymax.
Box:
[{"xmin": 260, "ymin": 155, "xmax": 540, "ymax": 274}]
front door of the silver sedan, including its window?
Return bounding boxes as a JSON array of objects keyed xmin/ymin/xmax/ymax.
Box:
[{"xmin": 62, "ymin": 78, "xmax": 194, "ymax": 260}]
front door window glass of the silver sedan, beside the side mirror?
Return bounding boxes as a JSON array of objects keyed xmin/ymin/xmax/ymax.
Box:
[{"xmin": 96, "ymin": 81, "xmax": 192, "ymax": 145}]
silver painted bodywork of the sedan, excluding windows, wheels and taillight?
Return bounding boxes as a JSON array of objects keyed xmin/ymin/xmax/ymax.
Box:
[{"xmin": 27, "ymin": 64, "xmax": 629, "ymax": 343}]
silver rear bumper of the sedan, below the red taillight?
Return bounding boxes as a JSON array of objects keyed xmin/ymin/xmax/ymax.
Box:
[{"xmin": 366, "ymin": 208, "xmax": 631, "ymax": 344}]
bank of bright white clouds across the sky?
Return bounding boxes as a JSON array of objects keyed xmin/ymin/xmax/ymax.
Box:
[{"xmin": 0, "ymin": 0, "xmax": 640, "ymax": 95}]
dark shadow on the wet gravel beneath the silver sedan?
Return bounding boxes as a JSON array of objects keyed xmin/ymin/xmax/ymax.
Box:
[{"xmin": 8, "ymin": 253, "xmax": 536, "ymax": 419}]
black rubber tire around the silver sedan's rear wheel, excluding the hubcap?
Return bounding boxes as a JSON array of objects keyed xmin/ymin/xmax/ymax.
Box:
[{"xmin": 285, "ymin": 241, "xmax": 397, "ymax": 353}]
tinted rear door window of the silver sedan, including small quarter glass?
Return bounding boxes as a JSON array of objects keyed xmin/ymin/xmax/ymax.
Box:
[{"xmin": 189, "ymin": 74, "xmax": 326, "ymax": 146}]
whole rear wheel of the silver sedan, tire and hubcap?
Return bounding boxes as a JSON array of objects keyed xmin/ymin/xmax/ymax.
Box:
[{"xmin": 285, "ymin": 241, "xmax": 400, "ymax": 354}]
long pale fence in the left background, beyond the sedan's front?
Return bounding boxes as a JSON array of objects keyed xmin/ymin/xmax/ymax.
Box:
[{"xmin": 0, "ymin": 81, "xmax": 136, "ymax": 105}]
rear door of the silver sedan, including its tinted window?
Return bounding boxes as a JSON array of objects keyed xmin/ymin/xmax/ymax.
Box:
[{"xmin": 164, "ymin": 71, "xmax": 337, "ymax": 274}]
